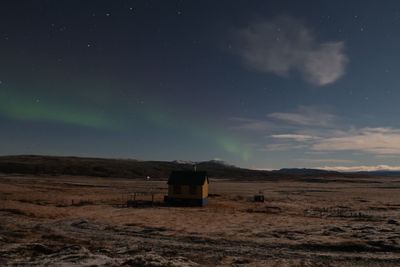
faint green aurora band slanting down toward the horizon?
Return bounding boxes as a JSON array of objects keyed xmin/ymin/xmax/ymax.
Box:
[{"xmin": 0, "ymin": 92, "xmax": 251, "ymax": 161}]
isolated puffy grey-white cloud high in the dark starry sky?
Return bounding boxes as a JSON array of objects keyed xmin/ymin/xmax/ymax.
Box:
[{"xmin": 236, "ymin": 17, "xmax": 348, "ymax": 86}]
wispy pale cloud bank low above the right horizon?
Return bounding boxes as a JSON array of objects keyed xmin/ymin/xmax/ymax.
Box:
[{"xmin": 234, "ymin": 106, "xmax": 400, "ymax": 163}]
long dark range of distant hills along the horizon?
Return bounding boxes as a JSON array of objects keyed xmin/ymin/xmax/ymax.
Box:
[{"xmin": 0, "ymin": 155, "xmax": 394, "ymax": 180}]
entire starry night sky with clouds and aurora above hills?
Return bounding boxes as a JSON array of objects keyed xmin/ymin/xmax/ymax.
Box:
[{"xmin": 0, "ymin": 0, "xmax": 400, "ymax": 170}]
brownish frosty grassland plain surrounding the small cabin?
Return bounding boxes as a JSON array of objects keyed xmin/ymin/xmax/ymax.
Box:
[{"xmin": 0, "ymin": 175, "xmax": 400, "ymax": 266}]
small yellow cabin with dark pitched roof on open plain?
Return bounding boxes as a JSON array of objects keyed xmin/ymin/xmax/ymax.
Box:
[{"xmin": 165, "ymin": 171, "xmax": 209, "ymax": 206}]
